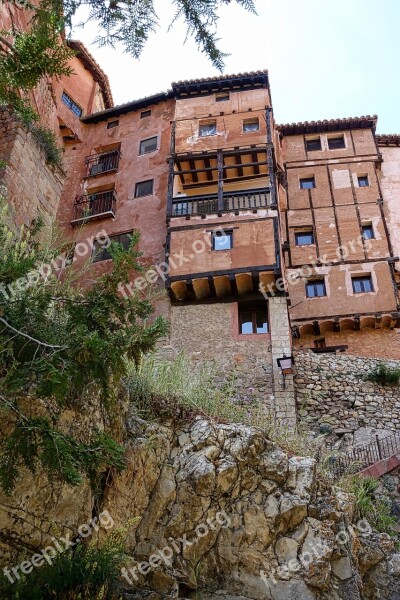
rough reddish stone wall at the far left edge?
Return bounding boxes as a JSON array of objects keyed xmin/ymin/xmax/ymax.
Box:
[{"xmin": 0, "ymin": 109, "xmax": 64, "ymax": 225}]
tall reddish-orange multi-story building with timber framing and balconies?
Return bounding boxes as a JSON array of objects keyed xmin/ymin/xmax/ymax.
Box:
[{"xmin": 2, "ymin": 21, "xmax": 400, "ymax": 422}]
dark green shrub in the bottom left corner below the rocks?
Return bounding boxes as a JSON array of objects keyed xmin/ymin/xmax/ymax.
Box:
[{"xmin": 0, "ymin": 529, "xmax": 127, "ymax": 600}]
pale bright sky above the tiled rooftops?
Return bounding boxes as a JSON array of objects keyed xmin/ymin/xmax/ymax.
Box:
[{"xmin": 74, "ymin": 0, "xmax": 400, "ymax": 133}]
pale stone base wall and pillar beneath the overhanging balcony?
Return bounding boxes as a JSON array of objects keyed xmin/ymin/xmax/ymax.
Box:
[{"xmin": 164, "ymin": 296, "xmax": 296, "ymax": 425}]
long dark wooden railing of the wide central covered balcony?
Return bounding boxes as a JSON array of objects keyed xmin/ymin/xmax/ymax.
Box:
[{"xmin": 172, "ymin": 188, "xmax": 271, "ymax": 217}]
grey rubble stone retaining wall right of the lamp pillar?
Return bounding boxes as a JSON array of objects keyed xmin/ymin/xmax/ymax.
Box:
[{"xmin": 295, "ymin": 350, "xmax": 400, "ymax": 434}]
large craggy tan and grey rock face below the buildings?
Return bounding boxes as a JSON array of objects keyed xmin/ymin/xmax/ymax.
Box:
[{"xmin": 0, "ymin": 416, "xmax": 400, "ymax": 600}]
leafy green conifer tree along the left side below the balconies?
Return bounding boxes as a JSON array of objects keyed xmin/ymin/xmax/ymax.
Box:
[{"xmin": 0, "ymin": 207, "xmax": 167, "ymax": 493}]
